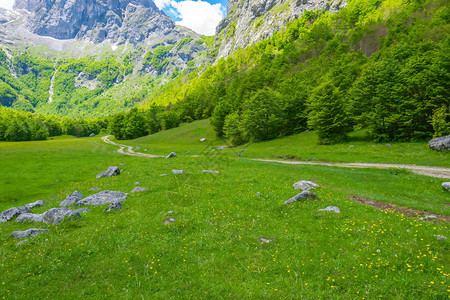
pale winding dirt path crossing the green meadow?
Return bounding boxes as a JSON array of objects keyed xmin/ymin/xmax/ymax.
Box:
[{"xmin": 102, "ymin": 135, "xmax": 450, "ymax": 179}]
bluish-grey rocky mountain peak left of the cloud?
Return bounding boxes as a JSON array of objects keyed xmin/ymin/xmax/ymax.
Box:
[{"xmin": 14, "ymin": 0, "xmax": 175, "ymax": 44}]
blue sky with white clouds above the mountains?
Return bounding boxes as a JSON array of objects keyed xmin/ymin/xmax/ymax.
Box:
[{"xmin": 0, "ymin": 0, "xmax": 228, "ymax": 35}]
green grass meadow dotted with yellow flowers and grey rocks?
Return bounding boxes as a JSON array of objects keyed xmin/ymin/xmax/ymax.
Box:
[{"xmin": 0, "ymin": 121, "xmax": 450, "ymax": 299}]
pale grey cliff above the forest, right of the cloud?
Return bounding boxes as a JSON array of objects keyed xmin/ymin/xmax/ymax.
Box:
[{"xmin": 216, "ymin": 0, "xmax": 346, "ymax": 59}]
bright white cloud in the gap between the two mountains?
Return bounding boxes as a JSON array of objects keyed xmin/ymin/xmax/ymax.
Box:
[{"xmin": 167, "ymin": 0, "xmax": 225, "ymax": 35}]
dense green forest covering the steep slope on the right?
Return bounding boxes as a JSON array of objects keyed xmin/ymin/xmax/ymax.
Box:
[{"xmin": 112, "ymin": 0, "xmax": 450, "ymax": 145}]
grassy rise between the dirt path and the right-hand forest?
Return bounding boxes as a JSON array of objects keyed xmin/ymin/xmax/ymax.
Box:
[{"xmin": 125, "ymin": 120, "xmax": 450, "ymax": 167}]
